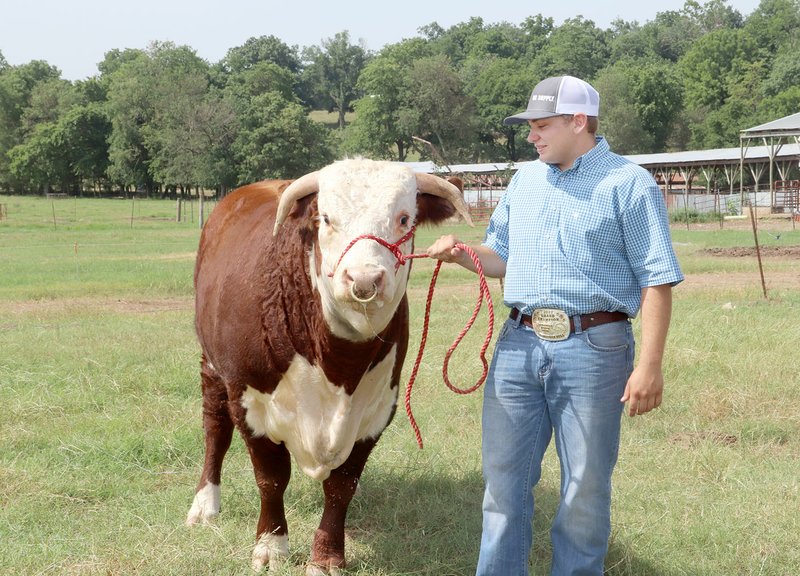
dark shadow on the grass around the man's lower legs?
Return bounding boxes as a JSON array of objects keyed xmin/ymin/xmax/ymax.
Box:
[{"xmin": 347, "ymin": 471, "xmax": 666, "ymax": 576}]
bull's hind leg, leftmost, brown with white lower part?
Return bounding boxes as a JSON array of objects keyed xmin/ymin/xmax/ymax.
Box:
[{"xmin": 186, "ymin": 358, "xmax": 234, "ymax": 526}]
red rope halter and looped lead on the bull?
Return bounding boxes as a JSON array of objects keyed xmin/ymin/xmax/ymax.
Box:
[{"xmin": 330, "ymin": 227, "xmax": 494, "ymax": 448}]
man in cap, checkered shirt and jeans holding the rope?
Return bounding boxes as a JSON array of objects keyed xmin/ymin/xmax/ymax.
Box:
[{"xmin": 428, "ymin": 76, "xmax": 683, "ymax": 576}]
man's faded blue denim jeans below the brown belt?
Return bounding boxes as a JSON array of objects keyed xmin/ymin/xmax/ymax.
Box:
[{"xmin": 477, "ymin": 319, "xmax": 634, "ymax": 576}]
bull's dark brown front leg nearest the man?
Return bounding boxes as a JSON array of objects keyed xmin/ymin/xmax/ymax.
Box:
[{"xmin": 306, "ymin": 438, "xmax": 377, "ymax": 576}]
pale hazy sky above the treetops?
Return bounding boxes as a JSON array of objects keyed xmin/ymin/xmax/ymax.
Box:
[{"xmin": 0, "ymin": 0, "xmax": 759, "ymax": 80}]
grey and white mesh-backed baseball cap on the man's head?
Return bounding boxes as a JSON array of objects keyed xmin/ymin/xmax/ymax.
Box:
[{"xmin": 503, "ymin": 76, "xmax": 600, "ymax": 124}]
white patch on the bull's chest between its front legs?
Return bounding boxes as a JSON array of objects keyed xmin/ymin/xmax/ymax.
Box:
[{"xmin": 242, "ymin": 347, "xmax": 397, "ymax": 480}]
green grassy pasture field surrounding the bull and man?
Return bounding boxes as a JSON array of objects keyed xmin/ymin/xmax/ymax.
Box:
[{"xmin": 0, "ymin": 196, "xmax": 800, "ymax": 576}]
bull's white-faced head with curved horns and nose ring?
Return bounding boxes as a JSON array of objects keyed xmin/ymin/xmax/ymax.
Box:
[{"xmin": 274, "ymin": 159, "xmax": 472, "ymax": 340}]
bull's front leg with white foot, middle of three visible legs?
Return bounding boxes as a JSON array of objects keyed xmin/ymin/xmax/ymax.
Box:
[{"xmin": 243, "ymin": 432, "xmax": 291, "ymax": 570}]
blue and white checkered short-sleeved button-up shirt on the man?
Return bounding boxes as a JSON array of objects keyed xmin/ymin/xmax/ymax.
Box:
[{"xmin": 483, "ymin": 138, "xmax": 683, "ymax": 317}]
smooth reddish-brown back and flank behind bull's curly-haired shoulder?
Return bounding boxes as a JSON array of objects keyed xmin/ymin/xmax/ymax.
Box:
[{"xmin": 194, "ymin": 180, "xmax": 289, "ymax": 378}]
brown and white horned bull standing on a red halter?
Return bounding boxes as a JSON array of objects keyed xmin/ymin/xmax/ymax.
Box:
[{"xmin": 186, "ymin": 159, "xmax": 471, "ymax": 574}]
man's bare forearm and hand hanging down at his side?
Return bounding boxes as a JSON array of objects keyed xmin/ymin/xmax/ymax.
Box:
[{"xmin": 621, "ymin": 284, "xmax": 672, "ymax": 416}]
